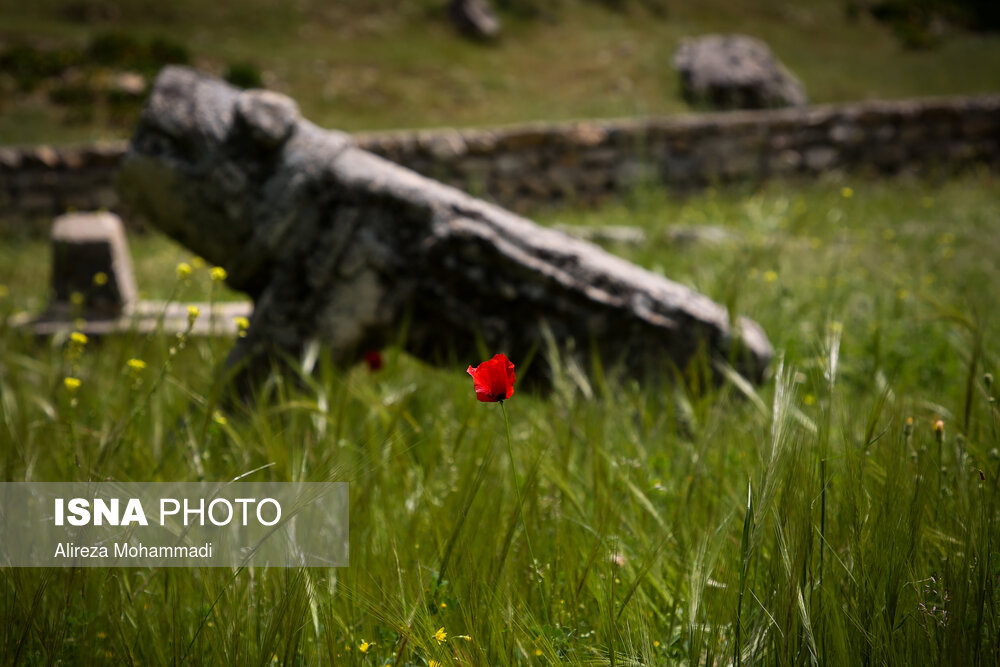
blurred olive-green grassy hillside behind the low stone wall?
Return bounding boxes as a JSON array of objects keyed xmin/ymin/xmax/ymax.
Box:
[{"xmin": 0, "ymin": 0, "xmax": 1000, "ymax": 143}]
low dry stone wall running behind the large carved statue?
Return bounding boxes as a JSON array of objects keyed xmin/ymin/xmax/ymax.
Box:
[{"xmin": 0, "ymin": 94, "xmax": 1000, "ymax": 223}]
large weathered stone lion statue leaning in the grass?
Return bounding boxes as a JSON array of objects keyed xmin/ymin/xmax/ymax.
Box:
[{"xmin": 120, "ymin": 68, "xmax": 771, "ymax": 388}]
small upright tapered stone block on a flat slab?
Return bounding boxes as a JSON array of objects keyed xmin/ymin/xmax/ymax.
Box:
[{"xmin": 49, "ymin": 213, "xmax": 136, "ymax": 319}]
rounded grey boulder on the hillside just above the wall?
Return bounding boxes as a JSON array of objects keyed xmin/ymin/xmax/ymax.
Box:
[{"xmin": 673, "ymin": 35, "xmax": 806, "ymax": 109}]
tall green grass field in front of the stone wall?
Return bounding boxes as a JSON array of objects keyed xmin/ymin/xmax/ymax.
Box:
[{"xmin": 0, "ymin": 172, "xmax": 1000, "ymax": 665}]
